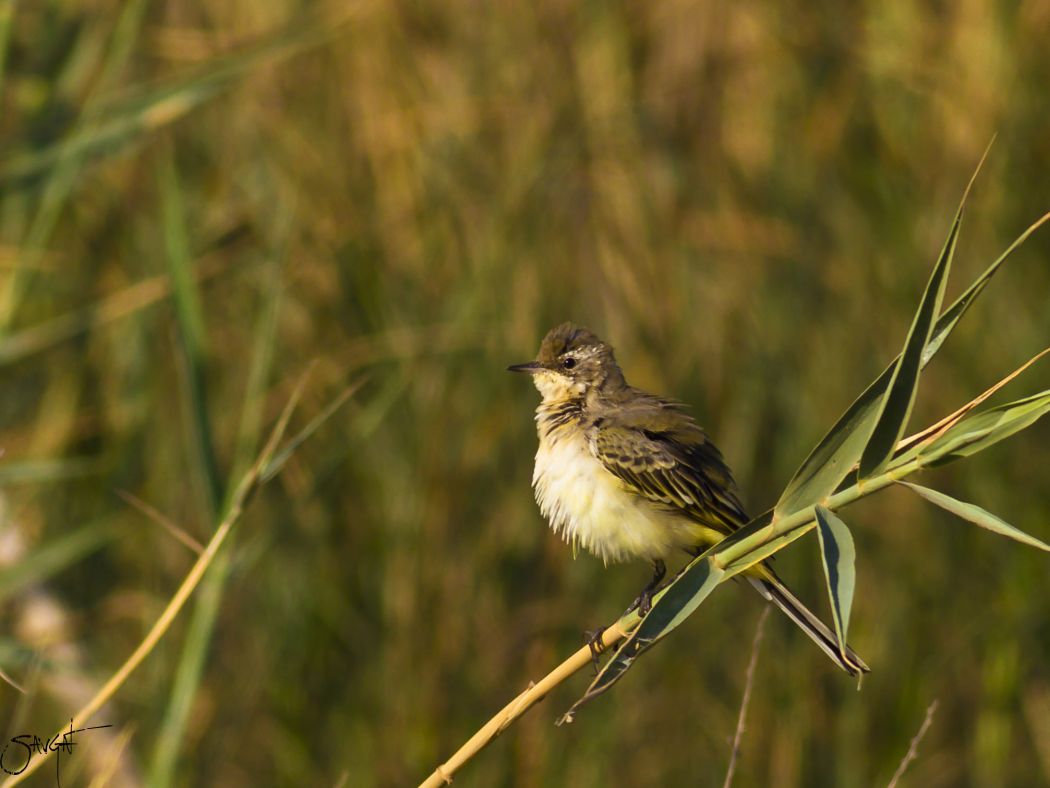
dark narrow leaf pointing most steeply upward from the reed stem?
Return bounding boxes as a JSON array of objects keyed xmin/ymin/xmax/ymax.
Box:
[{"xmin": 860, "ymin": 213, "xmax": 965, "ymax": 479}]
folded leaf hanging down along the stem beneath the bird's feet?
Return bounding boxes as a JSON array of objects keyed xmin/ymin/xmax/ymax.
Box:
[{"xmin": 559, "ymin": 557, "xmax": 726, "ymax": 723}]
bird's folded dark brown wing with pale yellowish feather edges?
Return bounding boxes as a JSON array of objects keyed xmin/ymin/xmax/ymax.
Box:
[{"xmin": 587, "ymin": 399, "xmax": 748, "ymax": 534}]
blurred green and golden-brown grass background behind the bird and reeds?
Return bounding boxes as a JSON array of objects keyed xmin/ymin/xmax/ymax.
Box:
[{"xmin": 0, "ymin": 0, "xmax": 1050, "ymax": 786}]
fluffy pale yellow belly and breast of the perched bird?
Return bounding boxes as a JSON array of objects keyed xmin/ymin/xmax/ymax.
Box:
[{"xmin": 532, "ymin": 433, "xmax": 707, "ymax": 563}]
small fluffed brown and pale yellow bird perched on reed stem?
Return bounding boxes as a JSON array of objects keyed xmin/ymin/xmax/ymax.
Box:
[{"xmin": 507, "ymin": 323, "xmax": 869, "ymax": 676}]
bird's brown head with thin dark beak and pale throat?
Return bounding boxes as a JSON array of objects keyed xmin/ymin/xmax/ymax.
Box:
[{"xmin": 507, "ymin": 323, "xmax": 624, "ymax": 401}]
